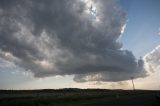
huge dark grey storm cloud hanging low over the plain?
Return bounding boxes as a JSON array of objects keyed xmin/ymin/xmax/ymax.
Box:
[{"xmin": 0, "ymin": 0, "xmax": 146, "ymax": 82}]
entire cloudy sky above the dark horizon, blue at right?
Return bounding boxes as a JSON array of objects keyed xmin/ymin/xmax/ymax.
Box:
[{"xmin": 0, "ymin": 0, "xmax": 160, "ymax": 90}]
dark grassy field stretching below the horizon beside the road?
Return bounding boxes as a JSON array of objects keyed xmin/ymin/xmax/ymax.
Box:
[{"xmin": 0, "ymin": 89, "xmax": 160, "ymax": 106}]
